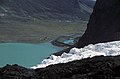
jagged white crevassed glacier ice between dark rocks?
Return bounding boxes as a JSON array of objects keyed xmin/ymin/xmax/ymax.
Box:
[{"xmin": 31, "ymin": 41, "xmax": 120, "ymax": 69}]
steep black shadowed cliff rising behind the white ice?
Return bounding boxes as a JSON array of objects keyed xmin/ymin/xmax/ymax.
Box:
[{"xmin": 77, "ymin": 0, "xmax": 120, "ymax": 48}]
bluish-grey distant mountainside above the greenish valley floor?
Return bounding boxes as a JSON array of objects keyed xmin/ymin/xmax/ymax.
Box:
[{"xmin": 0, "ymin": 0, "xmax": 95, "ymax": 20}]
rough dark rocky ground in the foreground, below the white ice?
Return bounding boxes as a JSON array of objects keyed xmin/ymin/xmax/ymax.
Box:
[{"xmin": 0, "ymin": 56, "xmax": 120, "ymax": 79}]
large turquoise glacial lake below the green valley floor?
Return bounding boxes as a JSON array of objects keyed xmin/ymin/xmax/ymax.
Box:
[{"xmin": 0, "ymin": 42, "xmax": 60, "ymax": 67}]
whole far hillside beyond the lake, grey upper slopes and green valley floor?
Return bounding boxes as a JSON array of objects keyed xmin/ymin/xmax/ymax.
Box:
[{"xmin": 0, "ymin": 0, "xmax": 95, "ymax": 43}]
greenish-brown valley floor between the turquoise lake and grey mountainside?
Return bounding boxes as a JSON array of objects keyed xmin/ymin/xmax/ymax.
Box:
[{"xmin": 0, "ymin": 20, "xmax": 87, "ymax": 43}]
